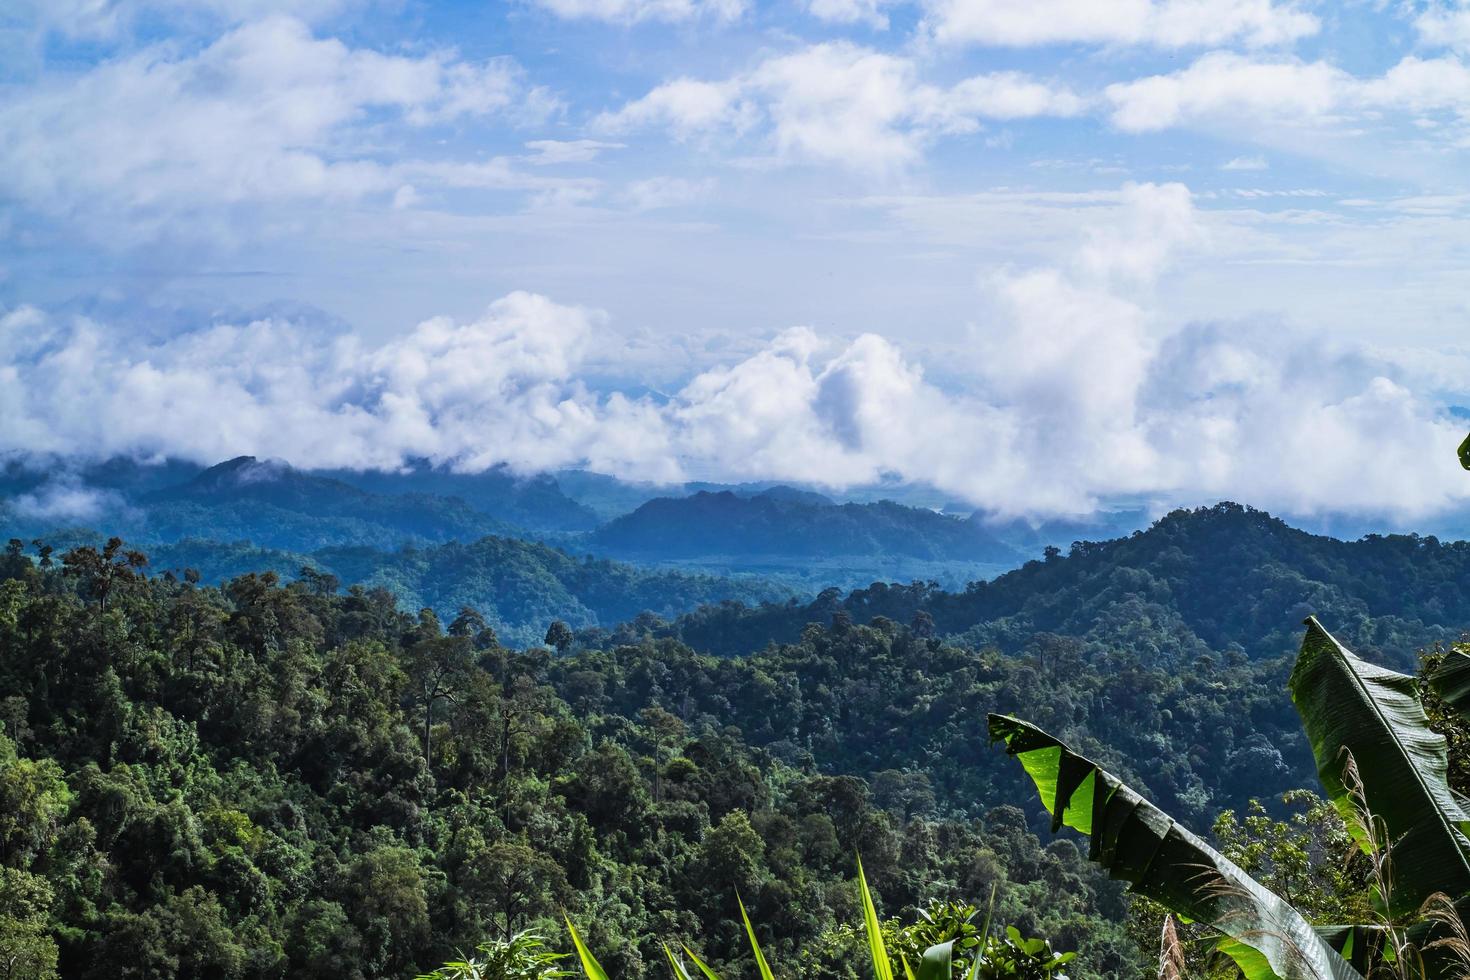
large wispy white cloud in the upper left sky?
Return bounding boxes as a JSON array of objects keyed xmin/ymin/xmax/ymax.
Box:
[{"xmin": 0, "ymin": 16, "xmax": 553, "ymax": 238}]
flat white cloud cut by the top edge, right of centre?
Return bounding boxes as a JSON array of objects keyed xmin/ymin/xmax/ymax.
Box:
[{"xmin": 923, "ymin": 0, "xmax": 1320, "ymax": 48}]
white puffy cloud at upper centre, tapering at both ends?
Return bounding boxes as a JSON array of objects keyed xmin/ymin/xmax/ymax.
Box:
[{"xmin": 595, "ymin": 41, "xmax": 1086, "ymax": 172}]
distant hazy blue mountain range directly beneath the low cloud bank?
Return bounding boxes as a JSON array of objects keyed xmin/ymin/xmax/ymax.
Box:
[{"xmin": 0, "ymin": 457, "xmax": 1036, "ymax": 590}]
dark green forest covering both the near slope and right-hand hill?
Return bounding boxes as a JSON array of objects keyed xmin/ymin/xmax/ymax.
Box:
[{"xmin": 0, "ymin": 504, "xmax": 1470, "ymax": 980}]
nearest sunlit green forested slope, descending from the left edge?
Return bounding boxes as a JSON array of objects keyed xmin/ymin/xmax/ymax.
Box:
[{"xmin": 0, "ymin": 544, "xmax": 1146, "ymax": 980}]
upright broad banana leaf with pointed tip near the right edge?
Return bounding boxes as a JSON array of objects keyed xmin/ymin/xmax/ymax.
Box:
[{"xmin": 1289, "ymin": 617, "xmax": 1470, "ymax": 918}]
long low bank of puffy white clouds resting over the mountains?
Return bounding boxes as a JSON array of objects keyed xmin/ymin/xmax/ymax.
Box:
[{"xmin": 0, "ymin": 184, "xmax": 1470, "ymax": 516}]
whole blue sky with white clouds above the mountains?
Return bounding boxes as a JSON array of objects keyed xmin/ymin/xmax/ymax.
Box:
[{"xmin": 0, "ymin": 0, "xmax": 1470, "ymax": 522}]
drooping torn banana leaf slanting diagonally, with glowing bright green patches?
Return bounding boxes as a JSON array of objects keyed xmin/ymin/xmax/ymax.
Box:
[{"xmin": 989, "ymin": 714, "xmax": 1363, "ymax": 980}]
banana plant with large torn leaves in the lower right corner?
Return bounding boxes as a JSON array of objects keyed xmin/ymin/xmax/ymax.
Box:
[{"xmin": 989, "ymin": 619, "xmax": 1470, "ymax": 980}]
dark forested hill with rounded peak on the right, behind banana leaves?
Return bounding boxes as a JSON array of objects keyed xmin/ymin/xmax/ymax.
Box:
[{"xmin": 667, "ymin": 502, "xmax": 1470, "ymax": 664}]
